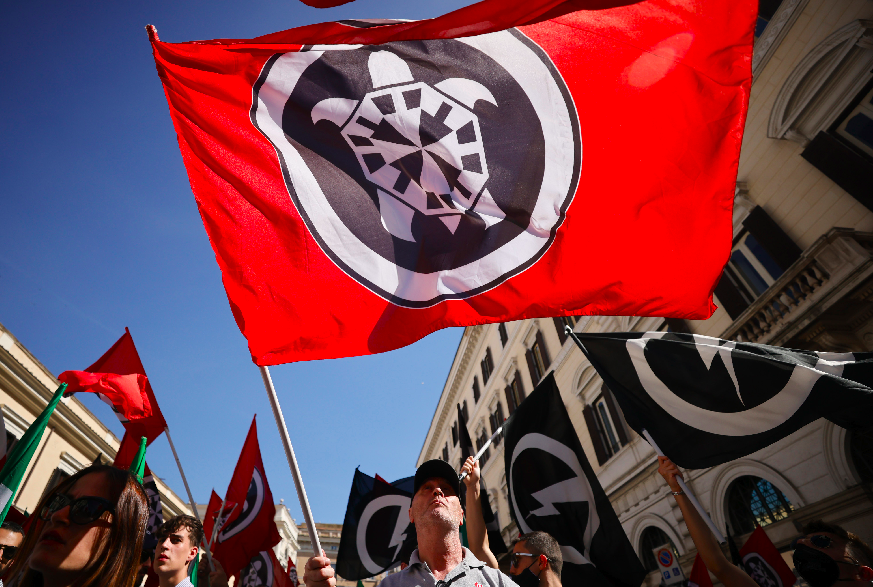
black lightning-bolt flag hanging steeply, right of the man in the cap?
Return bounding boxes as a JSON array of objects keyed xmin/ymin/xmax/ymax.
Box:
[{"xmin": 504, "ymin": 373, "xmax": 646, "ymax": 587}]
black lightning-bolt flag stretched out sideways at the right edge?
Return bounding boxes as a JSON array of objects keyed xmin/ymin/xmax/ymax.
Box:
[{"xmin": 579, "ymin": 332, "xmax": 873, "ymax": 469}]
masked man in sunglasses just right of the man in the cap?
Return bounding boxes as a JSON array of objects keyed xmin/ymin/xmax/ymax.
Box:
[{"xmin": 509, "ymin": 532, "xmax": 564, "ymax": 587}]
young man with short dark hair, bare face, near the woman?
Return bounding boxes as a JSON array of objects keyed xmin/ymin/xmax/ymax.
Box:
[{"xmin": 152, "ymin": 515, "xmax": 203, "ymax": 587}]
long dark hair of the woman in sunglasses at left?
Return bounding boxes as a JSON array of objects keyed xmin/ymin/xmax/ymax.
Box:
[{"xmin": 6, "ymin": 465, "xmax": 149, "ymax": 587}]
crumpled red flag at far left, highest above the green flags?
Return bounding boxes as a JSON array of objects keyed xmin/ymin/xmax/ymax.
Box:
[{"xmin": 59, "ymin": 328, "xmax": 167, "ymax": 469}]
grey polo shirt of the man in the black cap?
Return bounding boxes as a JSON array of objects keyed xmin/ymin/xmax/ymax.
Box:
[{"xmin": 379, "ymin": 548, "xmax": 517, "ymax": 587}]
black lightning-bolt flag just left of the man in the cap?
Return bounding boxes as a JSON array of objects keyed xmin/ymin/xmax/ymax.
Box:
[{"xmin": 336, "ymin": 469, "xmax": 417, "ymax": 581}]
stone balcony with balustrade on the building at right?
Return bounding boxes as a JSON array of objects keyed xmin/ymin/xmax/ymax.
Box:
[{"xmin": 722, "ymin": 228, "xmax": 873, "ymax": 345}]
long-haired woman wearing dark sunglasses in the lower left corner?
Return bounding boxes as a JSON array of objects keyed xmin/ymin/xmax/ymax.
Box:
[{"xmin": 6, "ymin": 465, "xmax": 149, "ymax": 587}]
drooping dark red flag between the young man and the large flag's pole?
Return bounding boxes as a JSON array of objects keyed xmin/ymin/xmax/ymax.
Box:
[{"xmin": 212, "ymin": 419, "xmax": 282, "ymax": 576}]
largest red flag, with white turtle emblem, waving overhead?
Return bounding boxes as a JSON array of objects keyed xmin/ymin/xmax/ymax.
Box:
[{"xmin": 151, "ymin": 0, "xmax": 756, "ymax": 365}]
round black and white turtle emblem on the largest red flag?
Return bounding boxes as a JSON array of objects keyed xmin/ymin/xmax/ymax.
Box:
[{"xmin": 251, "ymin": 30, "xmax": 581, "ymax": 307}]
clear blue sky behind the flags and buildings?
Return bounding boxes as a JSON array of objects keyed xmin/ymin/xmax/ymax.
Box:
[{"xmin": 0, "ymin": 0, "xmax": 469, "ymax": 523}]
